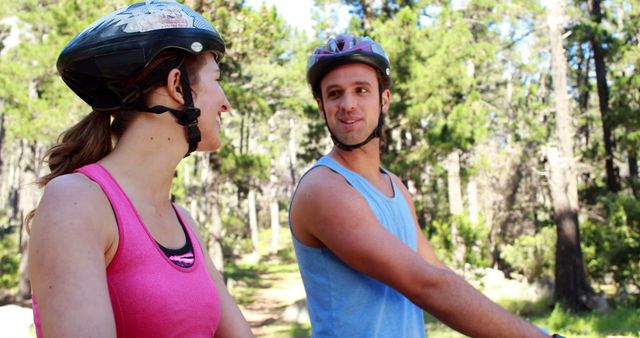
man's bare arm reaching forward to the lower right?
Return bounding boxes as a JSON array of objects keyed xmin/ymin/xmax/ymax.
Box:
[{"xmin": 291, "ymin": 168, "xmax": 544, "ymax": 337}]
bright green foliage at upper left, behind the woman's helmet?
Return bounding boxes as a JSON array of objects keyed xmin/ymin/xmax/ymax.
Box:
[{"xmin": 0, "ymin": 0, "xmax": 114, "ymax": 140}]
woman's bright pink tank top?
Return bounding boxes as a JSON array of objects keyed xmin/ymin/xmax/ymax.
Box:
[{"xmin": 33, "ymin": 163, "xmax": 220, "ymax": 338}]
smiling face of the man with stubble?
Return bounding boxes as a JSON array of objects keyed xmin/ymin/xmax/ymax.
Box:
[{"xmin": 317, "ymin": 63, "xmax": 390, "ymax": 144}]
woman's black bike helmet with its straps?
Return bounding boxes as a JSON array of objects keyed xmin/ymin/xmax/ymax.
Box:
[{"xmin": 57, "ymin": 0, "xmax": 225, "ymax": 155}]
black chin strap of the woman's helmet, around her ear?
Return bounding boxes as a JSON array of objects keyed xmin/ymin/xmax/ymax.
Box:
[{"xmin": 112, "ymin": 59, "xmax": 202, "ymax": 157}]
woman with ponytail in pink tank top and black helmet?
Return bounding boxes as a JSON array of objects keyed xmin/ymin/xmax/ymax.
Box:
[{"xmin": 29, "ymin": 1, "xmax": 252, "ymax": 338}]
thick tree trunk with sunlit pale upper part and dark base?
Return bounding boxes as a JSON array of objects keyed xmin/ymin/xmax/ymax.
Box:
[{"xmin": 547, "ymin": 1, "xmax": 591, "ymax": 312}]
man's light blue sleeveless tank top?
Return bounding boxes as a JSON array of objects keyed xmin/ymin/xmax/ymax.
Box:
[{"xmin": 289, "ymin": 156, "xmax": 425, "ymax": 338}]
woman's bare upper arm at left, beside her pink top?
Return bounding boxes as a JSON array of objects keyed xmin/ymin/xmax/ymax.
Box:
[{"xmin": 29, "ymin": 174, "xmax": 118, "ymax": 337}]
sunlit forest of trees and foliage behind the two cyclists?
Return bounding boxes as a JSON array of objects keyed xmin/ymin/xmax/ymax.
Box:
[{"xmin": 0, "ymin": 0, "xmax": 640, "ymax": 336}]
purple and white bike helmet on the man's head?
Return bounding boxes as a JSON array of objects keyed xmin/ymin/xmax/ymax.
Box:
[{"xmin": 307, "ymin": 34, "xmax": 391, "ymax": 88}]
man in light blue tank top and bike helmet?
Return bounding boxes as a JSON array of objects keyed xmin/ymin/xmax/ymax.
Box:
[{"xmin": 290, "ymin": 35, "xmax": 544, "ymax": 338}]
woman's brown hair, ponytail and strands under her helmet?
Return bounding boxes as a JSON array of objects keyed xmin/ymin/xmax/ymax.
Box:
[{"xmin": 25, "ymin": 50, "xmax": 205, "ymax": 229}]
